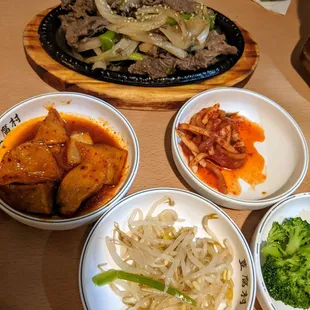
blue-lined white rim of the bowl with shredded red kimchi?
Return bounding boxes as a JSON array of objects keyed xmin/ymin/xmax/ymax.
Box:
[{"xmin": 172, "ymin": 87, "xmax": 309, "ymax": 207}]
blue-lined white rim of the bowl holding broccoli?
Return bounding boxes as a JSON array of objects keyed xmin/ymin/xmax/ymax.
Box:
[{"xmin": 251, "ymin": 192, "xmax": 310, "ymax": 310}]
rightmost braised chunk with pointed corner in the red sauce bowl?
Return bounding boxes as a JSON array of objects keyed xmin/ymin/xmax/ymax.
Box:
[{"xmin": 77, "ymin": 142, "xmax": 128, "ymax": 185}]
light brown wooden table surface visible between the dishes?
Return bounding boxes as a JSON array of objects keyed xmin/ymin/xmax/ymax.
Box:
[{"xmin": 0, "ymin": 0, "xmax": 310, "ymax": 310}]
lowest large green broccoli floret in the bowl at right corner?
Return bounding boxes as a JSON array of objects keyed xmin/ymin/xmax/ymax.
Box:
[{"xmin": 262, "ymin": 255, "xmax": 310, "ymax": 309}]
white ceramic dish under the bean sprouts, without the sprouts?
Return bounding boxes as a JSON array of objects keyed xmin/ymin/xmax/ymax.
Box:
[{"xmin": 79, "ymin": 188, "xmax": 256, "ymax": 310}]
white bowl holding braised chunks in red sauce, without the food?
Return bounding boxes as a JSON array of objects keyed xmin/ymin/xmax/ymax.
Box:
[{"xmin": 0, "ymin": 92, "xmax": 139, "ymax": 230}]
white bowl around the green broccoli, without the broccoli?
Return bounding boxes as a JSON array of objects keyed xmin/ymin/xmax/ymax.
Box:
[{"xmin": 251, "ymin": 193, "xmax": 310, "ymax": 310}]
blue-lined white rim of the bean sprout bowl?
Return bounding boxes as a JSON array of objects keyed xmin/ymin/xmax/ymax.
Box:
[{"xmin": 78, "ymin": 187, "xmax": 257, "ymax": 310}]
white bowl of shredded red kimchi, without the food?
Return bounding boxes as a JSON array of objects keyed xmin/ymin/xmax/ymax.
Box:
[{"xmin": 172, "ymin": 88, "xmax": 309, "ymax": 210}]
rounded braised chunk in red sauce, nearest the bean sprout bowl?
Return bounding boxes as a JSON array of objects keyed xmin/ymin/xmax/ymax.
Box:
[{"xmin": 57, "ymin": 163, "xmax": 104, "ymax": 216}]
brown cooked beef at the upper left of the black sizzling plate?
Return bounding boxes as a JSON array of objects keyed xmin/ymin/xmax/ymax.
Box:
[{"xmin": 59, "ymin": 13, "xmax": 108, "ymax": 47}]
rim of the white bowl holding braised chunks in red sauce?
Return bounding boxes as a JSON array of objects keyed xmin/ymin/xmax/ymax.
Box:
[{"xmin": 0, "ymin": 92, "xmax": 140, "ymax": 225}]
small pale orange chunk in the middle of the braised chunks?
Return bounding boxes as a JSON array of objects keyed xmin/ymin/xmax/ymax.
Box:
[{"xmin": 67, "ymin": 132, "xmax": 94, "ymax": 165}]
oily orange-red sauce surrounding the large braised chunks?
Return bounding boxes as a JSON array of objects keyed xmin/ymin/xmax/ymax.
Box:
[{"xmin": 0, "ymin": 113, "xmax": 126, "ymax": 219}]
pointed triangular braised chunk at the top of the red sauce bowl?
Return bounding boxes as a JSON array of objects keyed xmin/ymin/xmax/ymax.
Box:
[{"xmin": 34, "ymin": 108, "xmax": 69, "ymax": 145}]
